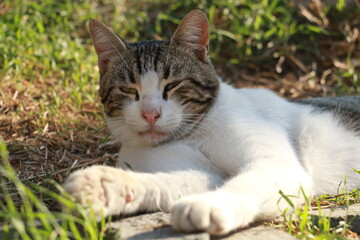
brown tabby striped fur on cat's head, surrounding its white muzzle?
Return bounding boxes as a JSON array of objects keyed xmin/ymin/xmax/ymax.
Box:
[{"xmin": 91, "ymin": 16, "xmax": 219, "ymax": 145}]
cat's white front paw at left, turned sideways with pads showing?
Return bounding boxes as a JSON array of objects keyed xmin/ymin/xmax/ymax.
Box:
[{"xmin": 63, "ymin": 166, "xmax": 145, "ymax": 218}]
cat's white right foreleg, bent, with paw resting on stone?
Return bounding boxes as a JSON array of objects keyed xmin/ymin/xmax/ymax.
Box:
[{"xmin": 171, "ymin": 154, "xmax": 311, "ymax": 235}]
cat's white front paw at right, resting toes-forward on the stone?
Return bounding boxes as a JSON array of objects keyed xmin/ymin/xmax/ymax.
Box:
[{"xmin": 171, "ymin": 192, "xmax": 255, "ymax": 235}]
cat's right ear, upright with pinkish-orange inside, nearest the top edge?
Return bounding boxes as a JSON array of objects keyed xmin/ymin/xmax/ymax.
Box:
[{"xmin": 171, "ymin": 9, "xmax": 209, "ymax": 61}]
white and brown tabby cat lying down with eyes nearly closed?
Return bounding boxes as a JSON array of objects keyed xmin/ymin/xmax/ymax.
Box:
[{"xmin": 64, "ymin": 10, "xmax": 360, "ymax": 235}]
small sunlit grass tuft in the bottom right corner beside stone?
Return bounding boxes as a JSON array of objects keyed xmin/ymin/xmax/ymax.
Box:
[{"xmin": 273, "ymin": 178, "xmax": 360, "ymax": 239}]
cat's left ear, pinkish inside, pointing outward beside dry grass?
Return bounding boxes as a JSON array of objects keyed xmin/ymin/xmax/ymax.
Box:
[{"xmin": 89, "ymin": 19, "xmax": 126, "ymax": 74}]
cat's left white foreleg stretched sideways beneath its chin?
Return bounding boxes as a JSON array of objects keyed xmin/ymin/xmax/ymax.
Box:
[{"xmin": 64, "ymin": 143, "xmax": 223, "ymax": 216}]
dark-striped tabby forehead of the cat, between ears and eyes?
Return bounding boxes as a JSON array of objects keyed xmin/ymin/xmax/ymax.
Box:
[{"xmin": 104, "ymin": 40, "xmax": 202, "ymax": 89}]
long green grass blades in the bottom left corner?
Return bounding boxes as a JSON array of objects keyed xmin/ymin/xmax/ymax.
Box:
[{"xmin": 0, "ymin": 139, "xmax": 110, "ymax": 240}]
